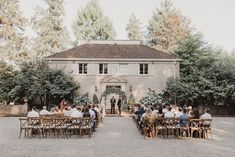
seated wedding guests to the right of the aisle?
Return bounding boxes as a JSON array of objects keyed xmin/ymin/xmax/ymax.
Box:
[{"xmin": 134, "ymin": 104, "xmax": 211, "ymax": 126}]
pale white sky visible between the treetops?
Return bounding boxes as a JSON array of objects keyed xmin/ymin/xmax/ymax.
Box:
[{"xmin": 20, "ymin": 0, "xmax": 235, "ymax": 51}]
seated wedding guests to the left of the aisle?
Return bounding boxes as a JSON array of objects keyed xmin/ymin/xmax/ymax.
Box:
[{"xmin": 27, "ymin": 104, "xmax": 100, "ymax": 131}]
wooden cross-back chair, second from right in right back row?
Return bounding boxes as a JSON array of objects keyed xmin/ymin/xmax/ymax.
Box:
[{"xmin": 190, "ymin": 119, "xmax": 202, "ymax": 138}]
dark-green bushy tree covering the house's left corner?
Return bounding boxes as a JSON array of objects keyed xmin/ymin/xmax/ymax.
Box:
[{"xmin": 9, "ymin": 61, "xmax": 79, "ymax": 105}]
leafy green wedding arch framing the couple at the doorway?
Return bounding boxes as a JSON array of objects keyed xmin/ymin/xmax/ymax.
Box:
[{"xmin": 100, "ymin": 87, "xmax": 127, "ymax": 113}]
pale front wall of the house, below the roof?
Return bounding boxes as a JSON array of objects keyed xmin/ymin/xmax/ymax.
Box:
[{"xmin": 50, "ymin": 61, "xmax": 179, "ymax": 101}]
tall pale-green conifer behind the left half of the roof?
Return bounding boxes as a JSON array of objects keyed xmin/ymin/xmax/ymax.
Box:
[{"xmin": 73, "ymin": 0, "xmax": 115, "ymax": 42}]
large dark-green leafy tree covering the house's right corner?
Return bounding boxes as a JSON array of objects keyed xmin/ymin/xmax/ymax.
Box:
[{"xmin": 165, "ymin": 34, "xmax": 235, "ymax": 105}]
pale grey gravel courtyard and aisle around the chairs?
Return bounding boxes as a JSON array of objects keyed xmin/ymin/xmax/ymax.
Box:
[{"xmin": 0, "ymin": 117, "xmax": 235, "ymax": 157}]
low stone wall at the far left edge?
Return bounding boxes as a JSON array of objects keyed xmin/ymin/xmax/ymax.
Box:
[{"xmin": 0, "ymin": 104, "xmax": 28, "ymax": 116}]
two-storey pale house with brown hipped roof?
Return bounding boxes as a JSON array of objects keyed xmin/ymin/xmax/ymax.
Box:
[{"xmin": 47, "ymin": 41, "xmax": 180, "ymax": 105}]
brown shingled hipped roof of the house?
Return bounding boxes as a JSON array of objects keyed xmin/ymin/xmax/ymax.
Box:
[{"xmin": 47, "ymin": 44, "xmax": 178, "ymax": 60}]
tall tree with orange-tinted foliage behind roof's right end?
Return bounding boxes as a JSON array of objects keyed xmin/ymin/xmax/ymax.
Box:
[{"xmin": 146, "ymin": 0, "xmax": 190, "ymax": 52}]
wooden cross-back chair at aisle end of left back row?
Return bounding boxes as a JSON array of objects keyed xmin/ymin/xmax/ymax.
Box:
[{"xmin": 80, "ymin": 117, "xmax": 92, "ymax": 138}]
